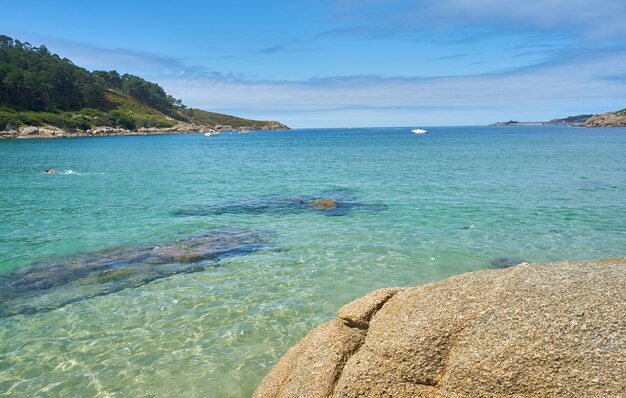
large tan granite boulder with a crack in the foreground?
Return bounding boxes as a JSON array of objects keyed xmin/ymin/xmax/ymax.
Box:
[{"xmin": 254, "ymin": 257, "xmax": 626, "ymax": 398}]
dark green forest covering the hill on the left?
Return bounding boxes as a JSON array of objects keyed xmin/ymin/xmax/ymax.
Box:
[{"xmin": 0, "ymin": 35, "xmax": 184, "ymax": 129}]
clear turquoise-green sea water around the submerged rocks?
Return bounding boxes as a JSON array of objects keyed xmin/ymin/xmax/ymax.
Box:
[{"xmin": 0, "ymin": 127, "xmax": 626, "ymax": 397}]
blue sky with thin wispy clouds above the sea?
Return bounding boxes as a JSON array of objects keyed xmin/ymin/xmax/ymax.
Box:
[{"xmin": 0, "ymin": 0, "xmax": 626, "ymax": 128}]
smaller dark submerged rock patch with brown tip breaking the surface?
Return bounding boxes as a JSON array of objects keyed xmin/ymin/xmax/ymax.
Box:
[{"xmin": 175, "ymin": 189, "xmax": 387, "ymax": 217}]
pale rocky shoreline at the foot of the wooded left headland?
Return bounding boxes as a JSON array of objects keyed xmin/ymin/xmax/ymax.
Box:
[{"xmin": 0, "ymin": 122, "xmax": 289, "ymax": 139}]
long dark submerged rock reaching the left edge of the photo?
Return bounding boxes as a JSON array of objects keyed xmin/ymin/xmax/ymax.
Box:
[{"xmin": 0, "ymin": 229, "xmax": 266, "ymax": 317}]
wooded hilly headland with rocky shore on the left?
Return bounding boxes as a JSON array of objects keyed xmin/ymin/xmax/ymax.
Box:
[{"xmin": 0, "ymin": 35, "xmax": 289, "ymax": 138}]
